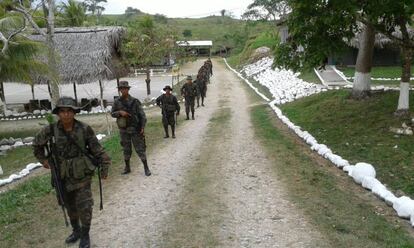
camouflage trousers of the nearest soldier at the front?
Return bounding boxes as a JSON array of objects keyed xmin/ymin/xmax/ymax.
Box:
[{"xmin": 63, "ymin": 183, "xmax": 93, "ymax": 229}]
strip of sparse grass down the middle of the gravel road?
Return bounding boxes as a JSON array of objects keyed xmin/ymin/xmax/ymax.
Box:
[{"xmin": 161, "ymin": 108, "xmax": 231, "ymax": 247}]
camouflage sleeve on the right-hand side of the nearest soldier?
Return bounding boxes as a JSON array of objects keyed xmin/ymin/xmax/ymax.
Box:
[{"xmin": 86, "ymin": 126, "xmax": 111, "ymax": 176}]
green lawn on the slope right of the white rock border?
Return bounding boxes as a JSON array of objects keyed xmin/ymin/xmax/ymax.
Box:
[{"xmin": 282, "ymin": 90, "xmax": 414, "ymax": 197}]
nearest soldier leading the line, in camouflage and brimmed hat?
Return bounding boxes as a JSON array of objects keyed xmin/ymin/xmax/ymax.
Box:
[{"xmin": 33, "ymin": 97, "xmax": 111, "ymax": 248}]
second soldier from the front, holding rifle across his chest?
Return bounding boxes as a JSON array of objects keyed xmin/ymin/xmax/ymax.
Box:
[{"xmin": 111, "ymin": 81, "xmax": 151, "ymax": 176}]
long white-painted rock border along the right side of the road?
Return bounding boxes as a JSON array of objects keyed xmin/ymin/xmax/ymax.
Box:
[{"xmin": 224, "ymin": 58, "xmax": 414, "ymax": 227}]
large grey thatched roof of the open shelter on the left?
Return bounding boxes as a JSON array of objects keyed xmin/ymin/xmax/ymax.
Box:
[{"xmin": 30, "ymin": 27, "xmax": 125, "ymax": 84}]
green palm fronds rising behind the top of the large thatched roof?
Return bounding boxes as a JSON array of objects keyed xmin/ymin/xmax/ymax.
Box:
[{"xmin": 62, "ymin": 0, "xmax": 86, "ymax": 27}]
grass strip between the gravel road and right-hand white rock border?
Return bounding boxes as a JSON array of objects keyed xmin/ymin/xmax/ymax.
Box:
[{"xmin": 251, "ymin": 103, "xmax": 414, "ymax": 248}]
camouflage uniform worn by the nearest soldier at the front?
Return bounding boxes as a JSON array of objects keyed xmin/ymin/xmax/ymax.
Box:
[{"xmin": 33, "ymin": 119, "xmax": 111, "ymax": 246}]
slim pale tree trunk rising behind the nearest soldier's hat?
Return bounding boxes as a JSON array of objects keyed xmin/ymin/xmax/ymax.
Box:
[{"xmin": 46, "ymin": 0, "xmax": 60, "ymax": 108}]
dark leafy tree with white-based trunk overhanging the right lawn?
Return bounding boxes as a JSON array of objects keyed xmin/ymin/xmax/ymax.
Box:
[{"xmin": 275, "ymin": 0, "xmax": 375, "ymax": 99}]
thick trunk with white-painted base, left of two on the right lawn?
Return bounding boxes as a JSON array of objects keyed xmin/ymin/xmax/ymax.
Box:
[{"xmin": 352, "ymin": 25, "xmax": 375, "ymax": 99}]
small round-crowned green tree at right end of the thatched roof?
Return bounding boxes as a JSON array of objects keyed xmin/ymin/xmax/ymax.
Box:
[{"xmin": 124, "ymin": 16, "xmax": 175, "ymax": 95}]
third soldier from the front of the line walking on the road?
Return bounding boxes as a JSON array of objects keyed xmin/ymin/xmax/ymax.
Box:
[{"xmin": 157, "ymin": 85, "xmax": 180, "ymax": 139}]
